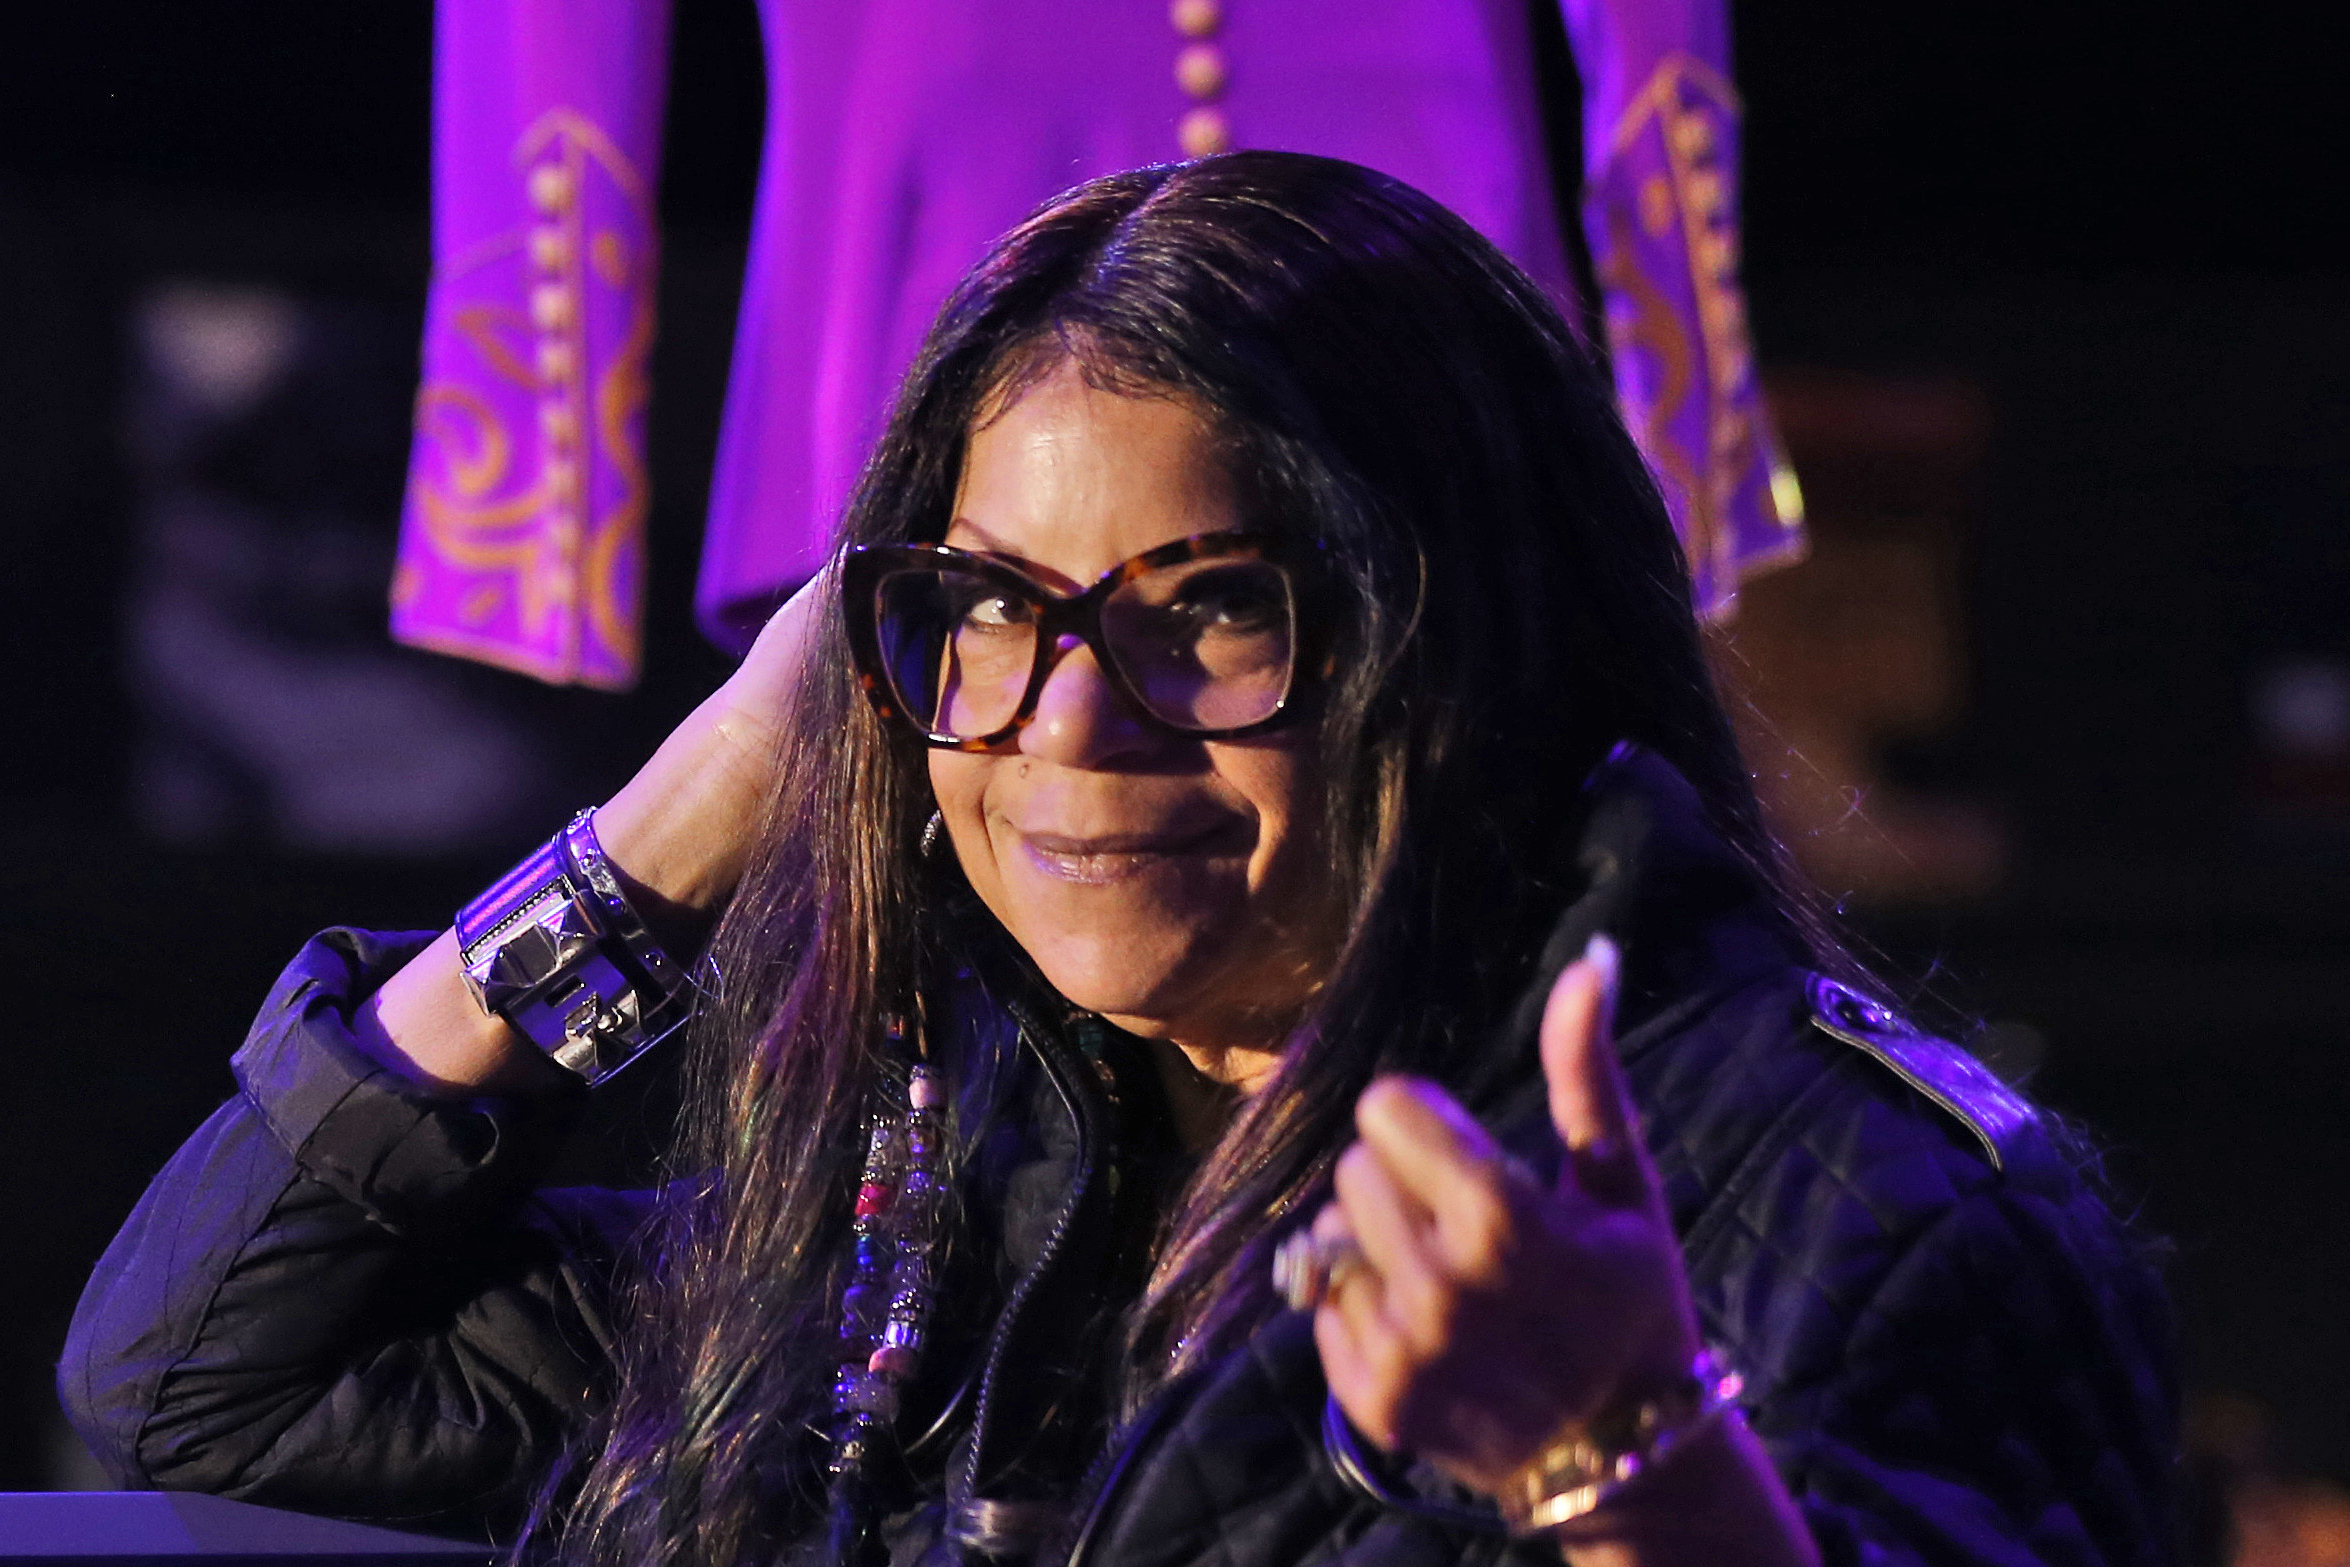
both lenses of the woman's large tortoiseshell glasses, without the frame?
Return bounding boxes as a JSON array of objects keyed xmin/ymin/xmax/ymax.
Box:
[{"xmin": 874, "ymin": 557, "xmax": 1297, "ymax": 740}]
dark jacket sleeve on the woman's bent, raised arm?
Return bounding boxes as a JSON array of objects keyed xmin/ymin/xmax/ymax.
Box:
[{"xmin": 59, "ymin": 930, "xmax": 649, "ymax": 1532}]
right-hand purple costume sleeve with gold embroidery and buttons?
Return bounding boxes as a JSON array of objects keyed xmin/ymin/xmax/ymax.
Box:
[{"xmin": 1560, "ymin": 0, "xmax": 1802, "ymax": 616}]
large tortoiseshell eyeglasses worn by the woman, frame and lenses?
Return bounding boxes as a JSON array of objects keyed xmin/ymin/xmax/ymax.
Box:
[{"xmin": 841, "ymin": 533, "xmax": 1297, "ymax": 752}]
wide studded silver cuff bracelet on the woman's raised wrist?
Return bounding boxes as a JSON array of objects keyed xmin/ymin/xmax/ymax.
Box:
[{"xmin": 456, "ymin": 811, "xmax": 693, "ymax": 1083}]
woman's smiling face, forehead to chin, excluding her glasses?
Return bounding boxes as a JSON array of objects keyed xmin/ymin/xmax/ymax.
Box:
[{"xmin": 931, "ymin": 364, "xmax": 1325, "ymax": 1076}]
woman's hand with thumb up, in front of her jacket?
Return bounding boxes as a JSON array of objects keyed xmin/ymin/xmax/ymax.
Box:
[{"xmin": 1314, "ymin": 940, "xmax": 1697, "ymax": 1492}]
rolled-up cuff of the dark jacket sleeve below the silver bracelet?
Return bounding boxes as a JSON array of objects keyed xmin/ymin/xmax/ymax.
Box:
[{"xmin": 230, "ymin": 928, "xmax": 585, "ymax": 1233}]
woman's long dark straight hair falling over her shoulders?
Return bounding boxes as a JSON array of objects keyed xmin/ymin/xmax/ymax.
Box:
[{"xmin": 540, "ymin": 153, "xmax": 1770, "ymax": 1567}]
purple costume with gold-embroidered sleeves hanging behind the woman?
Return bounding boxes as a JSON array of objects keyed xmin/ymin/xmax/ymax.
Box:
[{"xmin": 392, "ymin": 0, "xmax": 1802, "ymax": 686}]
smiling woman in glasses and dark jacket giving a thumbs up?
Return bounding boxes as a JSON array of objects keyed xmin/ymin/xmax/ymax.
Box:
[{"xmin": 63, "ymin": 153, "xmax": 2169, "ymax": 1567}]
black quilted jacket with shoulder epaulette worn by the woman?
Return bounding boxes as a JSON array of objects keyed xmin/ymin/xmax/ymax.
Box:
[{"xmin": 59, "ymin": 754, "xmax": 2174, "ymax": 1567}]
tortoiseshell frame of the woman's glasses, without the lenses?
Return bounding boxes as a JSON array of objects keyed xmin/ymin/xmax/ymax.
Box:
[{"xmin": 841, "ymin": 529, "xmax": 1314, "ymax": 752}]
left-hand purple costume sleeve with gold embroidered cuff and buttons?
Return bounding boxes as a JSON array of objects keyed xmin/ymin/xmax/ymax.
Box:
[{"xmin": 392, "ymin": 0, "xmax": 670, "ymax": 688}]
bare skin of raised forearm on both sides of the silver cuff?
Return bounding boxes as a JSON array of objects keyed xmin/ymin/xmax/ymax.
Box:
[{"xmin": 353, "ymin": 576, "xmax": 830, "ymax": 1097}]
